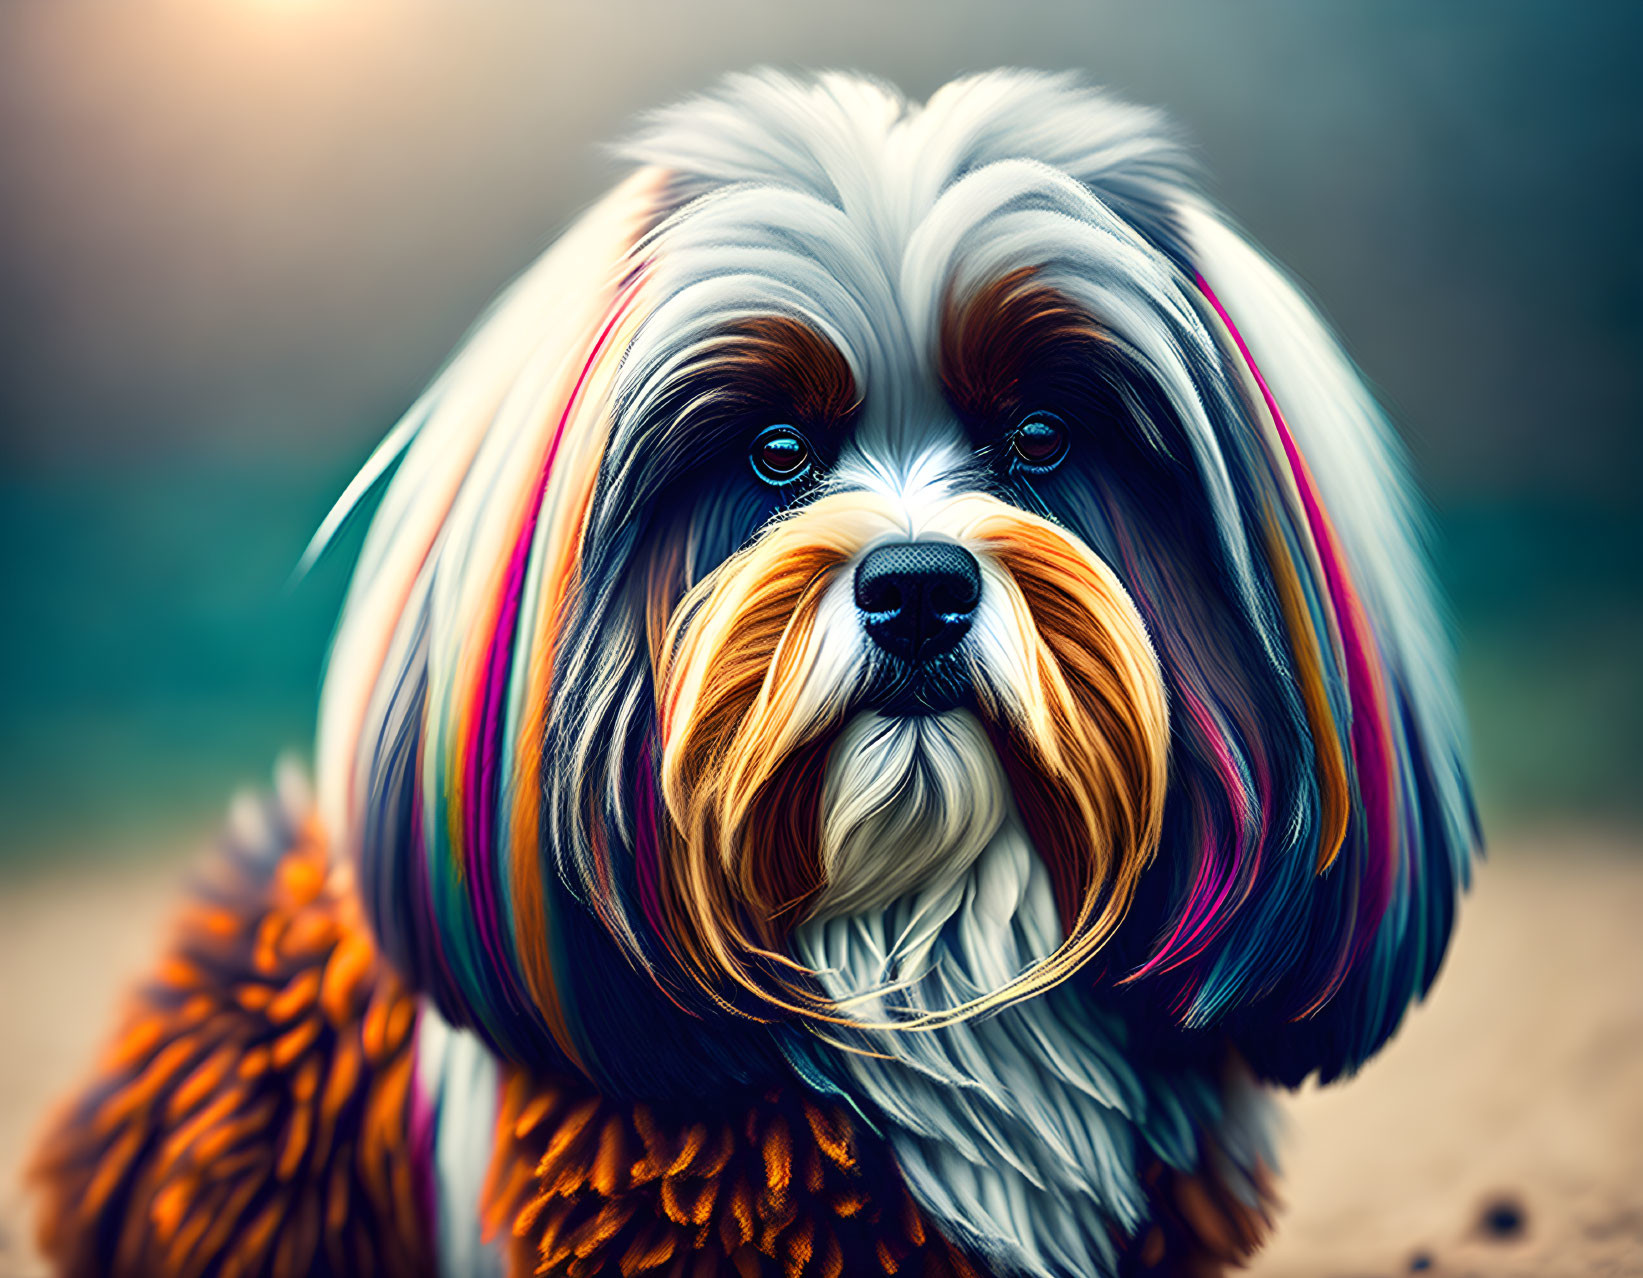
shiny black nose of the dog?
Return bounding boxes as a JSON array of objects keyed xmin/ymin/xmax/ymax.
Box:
[{"xmin": 856, "ymin": 542, "xmax": 981, "ymax": 662}]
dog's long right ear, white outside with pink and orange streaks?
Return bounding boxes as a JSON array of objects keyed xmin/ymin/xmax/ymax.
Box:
[{"xmin": 1129, "ymin": 200, "xmax": 1477, "ymax": 1084}]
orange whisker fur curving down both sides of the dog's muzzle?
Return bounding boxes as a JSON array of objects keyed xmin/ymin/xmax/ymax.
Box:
[{"xmin": 652, "ymin": 493, "xmax": 1168, "ymax": 1025}]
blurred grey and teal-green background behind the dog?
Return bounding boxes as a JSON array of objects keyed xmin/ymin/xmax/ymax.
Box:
[{"xmin": 0, "ymin": 0, "xmax": 1643, "ymax": 864}]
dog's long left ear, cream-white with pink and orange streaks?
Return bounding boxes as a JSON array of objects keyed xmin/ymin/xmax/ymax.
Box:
[{"xmin": 315, "ymin": 169, "xmax": 667, "ymax": 1060}]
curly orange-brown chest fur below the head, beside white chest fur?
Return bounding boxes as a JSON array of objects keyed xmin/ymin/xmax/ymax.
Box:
[{"xmin": 485, "ymin": 1071, "xmax": 981, "ymax": 1278}]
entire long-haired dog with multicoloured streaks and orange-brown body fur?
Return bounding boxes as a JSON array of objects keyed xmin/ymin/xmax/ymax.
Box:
[{"xmin": 35, "ymin": 72, "xmax": 1475, "ymax": 1278}]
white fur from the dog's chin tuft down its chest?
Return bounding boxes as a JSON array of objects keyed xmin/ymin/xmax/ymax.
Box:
[{"xmin": 790, "ymin": 710, "xmax": 1267, "ymax": 1278}]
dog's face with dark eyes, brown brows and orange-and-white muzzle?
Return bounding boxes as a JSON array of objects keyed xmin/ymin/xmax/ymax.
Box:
[{"xmin": 640, "ymin": 271, "xmax": 1168, "ymax": 1038}]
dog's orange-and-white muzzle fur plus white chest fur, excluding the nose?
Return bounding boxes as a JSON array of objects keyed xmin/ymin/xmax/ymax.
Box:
[{"xmin": 657, "ymin": 479, "xmax": 1221, "ymax": 1278}]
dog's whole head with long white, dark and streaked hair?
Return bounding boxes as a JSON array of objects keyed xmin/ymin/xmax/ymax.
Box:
[{"xmin": 319, "ymin": 74, "xmax": 1475, "ymax": 1091}]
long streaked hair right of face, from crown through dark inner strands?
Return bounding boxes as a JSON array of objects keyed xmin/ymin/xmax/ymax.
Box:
[{"xmin": 1014, "ymin": 77, "xmax": 1479, "ymax": 1084}]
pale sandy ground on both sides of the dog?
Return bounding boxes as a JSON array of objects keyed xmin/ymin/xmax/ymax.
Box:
[{"xmin": 0, "ymin": 833, "xmax": 1643, "ymax": 1278}]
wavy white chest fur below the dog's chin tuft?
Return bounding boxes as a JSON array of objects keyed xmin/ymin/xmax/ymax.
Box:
[{"xmin": 794, "ymin": 802, "xmax": 1143, "ymax": 1278}]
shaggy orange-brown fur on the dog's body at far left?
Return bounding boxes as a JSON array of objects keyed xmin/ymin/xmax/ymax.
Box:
[{"xmin": 30, "ymin": 811, "xmax": 430, "ymax": 1278}]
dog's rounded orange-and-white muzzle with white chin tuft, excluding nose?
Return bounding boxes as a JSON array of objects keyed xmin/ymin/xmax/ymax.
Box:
[{"xmin": 652, "ymin": 491, "xmax": 1168, "ymax": 1023}]
